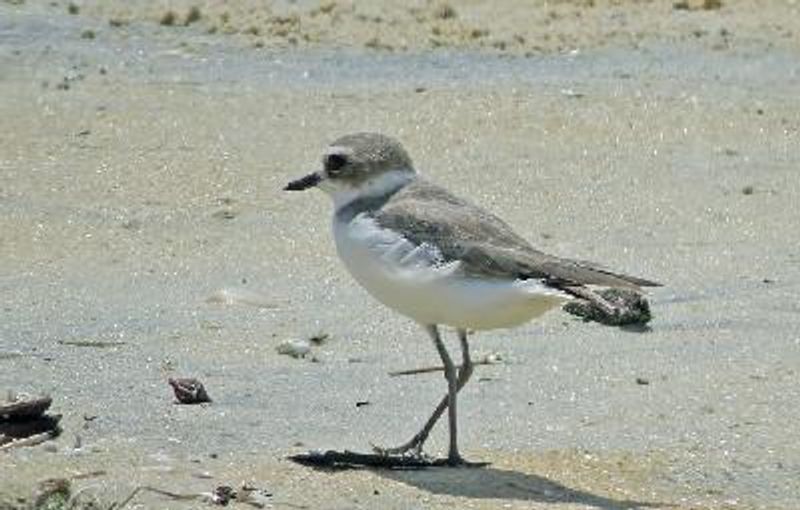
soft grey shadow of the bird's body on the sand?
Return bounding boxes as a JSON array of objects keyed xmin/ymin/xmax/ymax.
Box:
[{"xmin": 373, "ymin": 466, "xmax": 673, "ymax": 510}]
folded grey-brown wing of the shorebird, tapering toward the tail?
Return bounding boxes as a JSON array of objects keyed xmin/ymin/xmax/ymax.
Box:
[{"xmin": 373, "ymin": 180, "xmax": 660, "ymax": 291}]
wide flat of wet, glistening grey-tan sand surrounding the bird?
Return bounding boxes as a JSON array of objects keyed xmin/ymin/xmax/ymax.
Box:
[{"xmin": 0, "ymin": 2, "xmax": 800, "ymax": 509}]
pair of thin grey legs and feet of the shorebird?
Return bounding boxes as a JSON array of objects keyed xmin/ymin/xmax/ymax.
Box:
[{"xmin": 374, "ymin": 326, "xmax": 473, "ymax": 464}]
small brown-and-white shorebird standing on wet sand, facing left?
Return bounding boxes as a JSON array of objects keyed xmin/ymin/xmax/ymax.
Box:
[{"xmin": 284, "ymin": 133, "xmax": 659, "ymax": 465}]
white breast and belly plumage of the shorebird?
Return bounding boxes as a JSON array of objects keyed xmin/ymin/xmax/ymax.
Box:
[{"xmin": 334, "ymin": 216, "xmax": 569, "ymax": 329}]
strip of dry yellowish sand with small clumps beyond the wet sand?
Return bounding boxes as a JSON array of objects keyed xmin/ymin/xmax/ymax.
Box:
[{"xmin": 17, "ymin": 0, "xmax": 800, "ymax": 55}]
